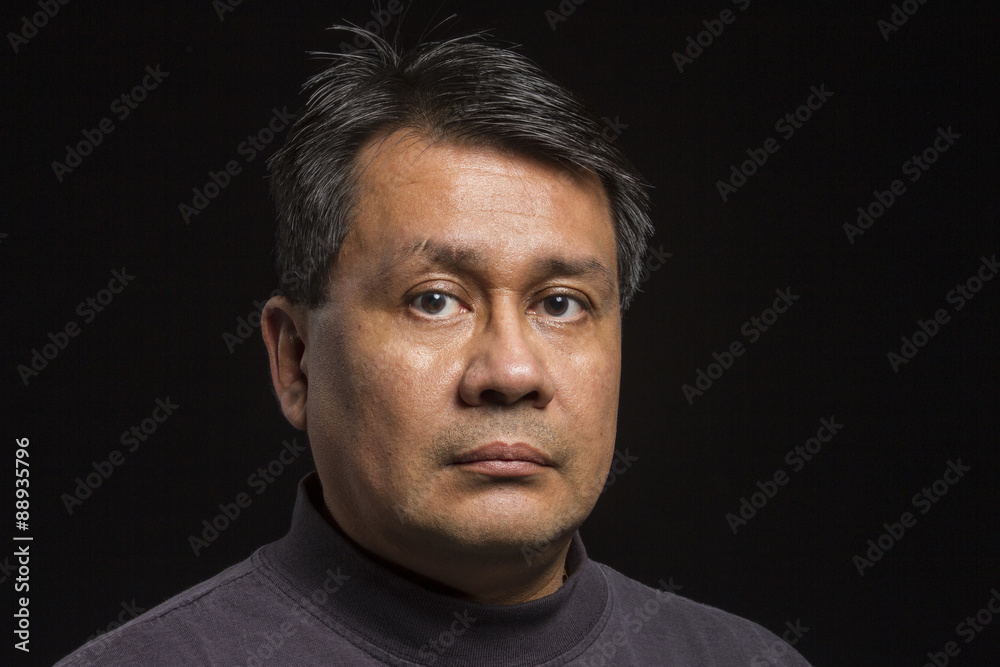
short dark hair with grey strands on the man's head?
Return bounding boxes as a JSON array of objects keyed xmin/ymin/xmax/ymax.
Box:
[{"xmin": 268, "ymin": 26, "xmax": 654, "ymax": 311}]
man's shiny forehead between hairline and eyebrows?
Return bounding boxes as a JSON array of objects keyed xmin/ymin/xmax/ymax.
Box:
[{"xmin": 345, "ymin": 130, "xmax": 616, "ymax": 270}]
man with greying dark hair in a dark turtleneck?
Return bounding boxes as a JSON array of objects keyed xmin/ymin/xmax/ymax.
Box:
[{"xmin": 54, "ymin": 27, "xmax": 807, "ymax": 666}]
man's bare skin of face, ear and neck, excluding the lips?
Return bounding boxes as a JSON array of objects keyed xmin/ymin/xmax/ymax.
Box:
[{"xmin": 261, "ymin": 131, "xmax": 621, "ymax": 604}]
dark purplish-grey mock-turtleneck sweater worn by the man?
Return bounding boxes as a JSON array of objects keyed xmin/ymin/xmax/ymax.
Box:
[{"xmin": 57, "ymin": 473, "xmax": 808, "ymax": 667}]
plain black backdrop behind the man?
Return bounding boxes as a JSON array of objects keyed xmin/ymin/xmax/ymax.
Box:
[{"xmin": 0, "ymin": 0, "xmax": 1000, "ymax": 665}]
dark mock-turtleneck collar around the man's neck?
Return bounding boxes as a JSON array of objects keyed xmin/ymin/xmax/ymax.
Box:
[{"xmin": 259, "ymin": 472, "xmax": 611, "ymax": 666}]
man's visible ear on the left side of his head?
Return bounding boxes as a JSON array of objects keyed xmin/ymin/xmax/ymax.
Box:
[{"xmin": 260, "ymin": 296, "xmax": 309, "ymax": 431}]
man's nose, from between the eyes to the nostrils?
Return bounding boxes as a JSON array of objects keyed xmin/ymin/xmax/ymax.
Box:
[{"xmin": 459, "ymin": 304, "xmax": 555, "ymax": 408}]
